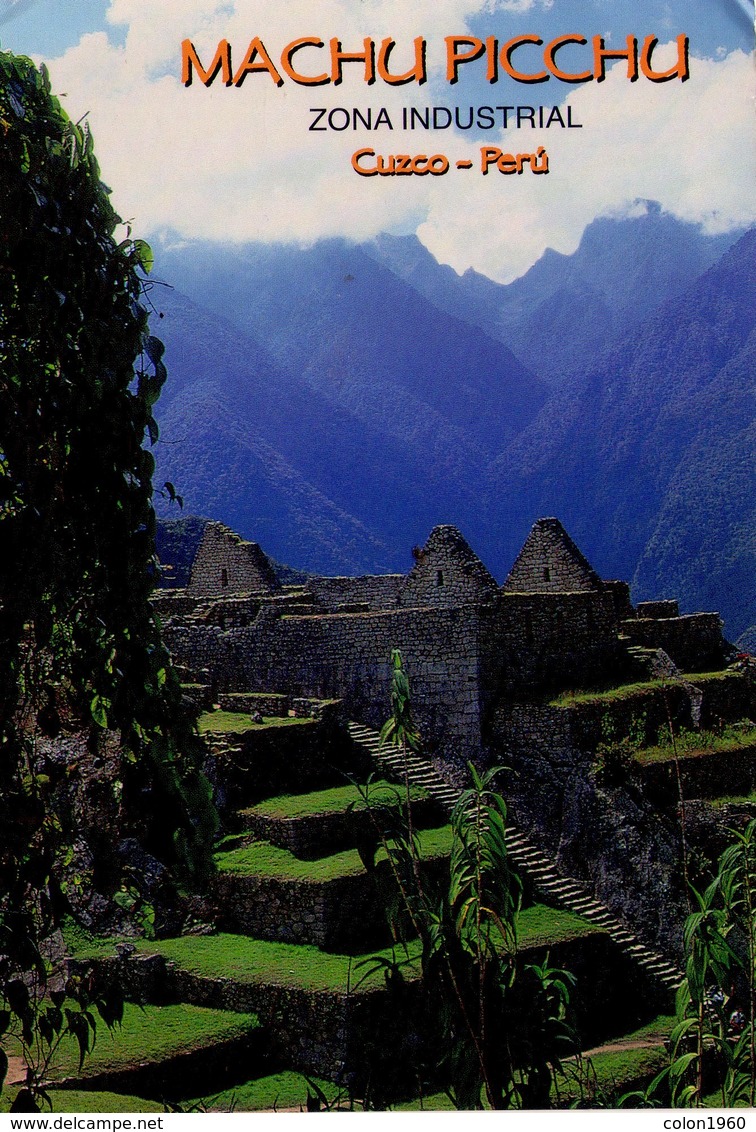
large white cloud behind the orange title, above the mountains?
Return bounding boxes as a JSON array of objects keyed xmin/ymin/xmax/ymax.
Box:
[{"xmin": 44, "ymin": 0, "xmax": 756, "ymax": 280}]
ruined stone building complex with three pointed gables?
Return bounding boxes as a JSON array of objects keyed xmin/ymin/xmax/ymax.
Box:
[{"xmin": 157, "ymin": 518, "xmax": 727, "ymax": 767}]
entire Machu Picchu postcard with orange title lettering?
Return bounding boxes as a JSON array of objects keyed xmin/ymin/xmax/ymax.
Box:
[{"xmin": 0, "ymin": 0, "xmax": 756, "ymax": 1127}]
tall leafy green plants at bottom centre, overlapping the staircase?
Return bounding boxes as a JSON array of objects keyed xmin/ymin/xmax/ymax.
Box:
[{"xmin": 357, "ymin": 651, "xmax": 574, "ymax": 1109}]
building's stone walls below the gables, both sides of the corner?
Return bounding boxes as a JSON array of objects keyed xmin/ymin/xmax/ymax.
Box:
[{"xmin": 165, "ymin": 592, "xmax": 622, "ymax": 770}]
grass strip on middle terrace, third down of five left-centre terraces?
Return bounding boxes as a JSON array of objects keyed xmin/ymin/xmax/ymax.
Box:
[{"xmin": 215, "ymin": 825, "xmax": 452, "ymax": 883}]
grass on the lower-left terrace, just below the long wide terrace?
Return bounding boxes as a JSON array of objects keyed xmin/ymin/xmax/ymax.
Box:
[{"xmin": 3, "ymin": 1003, "xmax": 259, "ymax": 1080}]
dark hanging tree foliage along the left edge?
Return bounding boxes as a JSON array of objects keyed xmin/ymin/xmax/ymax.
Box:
[{"xmin": 0, "ymin": 53, "xmax": 214, "ymax": 1104}]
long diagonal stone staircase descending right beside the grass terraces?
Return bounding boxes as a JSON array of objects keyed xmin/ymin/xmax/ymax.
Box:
[{"xmin": 349, "ymin": 721, "xmax": 682, "ymax": 991}]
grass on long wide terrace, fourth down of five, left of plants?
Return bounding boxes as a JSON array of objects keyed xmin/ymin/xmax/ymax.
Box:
[{"xmin": 138, "ymin": 934, "xmax": 420, "ymax": 994}]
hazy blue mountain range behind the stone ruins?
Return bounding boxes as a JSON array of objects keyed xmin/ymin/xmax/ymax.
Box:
[{"xmin": 151, "ymin": 203, "xmax": 756, "ymax": 637}]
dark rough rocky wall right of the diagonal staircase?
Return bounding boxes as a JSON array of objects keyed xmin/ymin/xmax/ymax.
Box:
[{"xmin": 489, "ymin": 703, "xmax": 687, "ymax": 953}]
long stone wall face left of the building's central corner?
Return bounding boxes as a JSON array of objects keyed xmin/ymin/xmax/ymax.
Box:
[{"xmin": 165, "ymin": 607, "xmax": 481, "ymax": 765}]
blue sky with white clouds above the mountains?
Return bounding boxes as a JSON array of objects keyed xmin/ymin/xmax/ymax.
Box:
[{"xmin": 0, "ymin": 0, "xmax": 756, "ymax": 282}]
